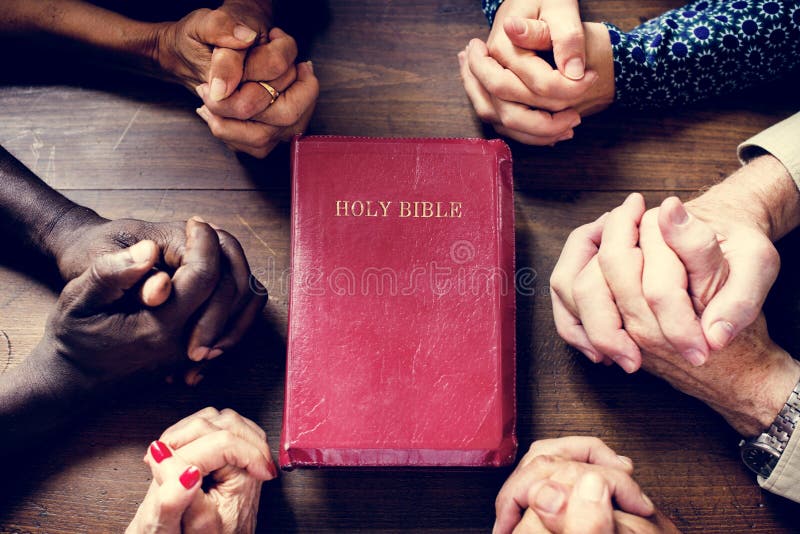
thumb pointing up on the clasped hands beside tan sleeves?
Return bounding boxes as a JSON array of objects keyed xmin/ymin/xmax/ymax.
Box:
[{"xmin": 658, "ymin": 197, "xmax": 728, "ymax": 315}]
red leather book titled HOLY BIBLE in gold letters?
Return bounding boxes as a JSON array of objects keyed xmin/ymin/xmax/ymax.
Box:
[{"xmin": 280, "ymin": 137, "xmax": 517, "ymax": 468}]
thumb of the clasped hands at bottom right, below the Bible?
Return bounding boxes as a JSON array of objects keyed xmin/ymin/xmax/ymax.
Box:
[{"xmin": 564, "ymin": 471, "xmax": 614, "ymax": 534}]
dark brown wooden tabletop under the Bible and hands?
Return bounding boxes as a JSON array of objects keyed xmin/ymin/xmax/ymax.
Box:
[{"xmin": 0, "ymin": 0, "xmax": 800, "ymax": 533}]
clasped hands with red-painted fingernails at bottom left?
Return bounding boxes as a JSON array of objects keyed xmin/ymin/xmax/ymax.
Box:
[{"xmin": 126, "ymin": 407, "xmax": 278, "ymax": 534}]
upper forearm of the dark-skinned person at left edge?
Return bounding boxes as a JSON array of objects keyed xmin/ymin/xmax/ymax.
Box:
[{"xmin": 0, "ymin": 147, "xmax": 104, "ymax": 270}]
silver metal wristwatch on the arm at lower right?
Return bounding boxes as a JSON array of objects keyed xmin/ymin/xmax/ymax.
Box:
[{"xmin": 739, "ymin": 382, "xmax": 800, "ymax": 478}]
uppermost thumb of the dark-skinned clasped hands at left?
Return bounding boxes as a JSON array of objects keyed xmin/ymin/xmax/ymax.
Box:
[{"xmin": 63, "ymin": 240, "xmax": 158, "ymax": 312}]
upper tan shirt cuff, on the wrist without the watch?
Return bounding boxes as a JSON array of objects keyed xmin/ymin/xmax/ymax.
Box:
[{"xmin": 738, "ymin": 113, "xmax": 800, "ymax": 193}]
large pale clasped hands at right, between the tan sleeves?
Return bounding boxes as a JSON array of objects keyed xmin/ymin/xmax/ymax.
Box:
[{"xmin": 551, "ymin": 194, "xmax": 780, "ymax": 372}]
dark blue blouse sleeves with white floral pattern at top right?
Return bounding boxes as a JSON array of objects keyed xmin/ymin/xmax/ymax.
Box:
[{"xmin": 482, "ymin": 0, "xmax": 800, "ymax": 109}]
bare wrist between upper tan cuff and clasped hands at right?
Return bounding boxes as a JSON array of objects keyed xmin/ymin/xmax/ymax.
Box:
[{"xmin": 687, "ymin": 154, "xmax": 800, "ymax": 241}]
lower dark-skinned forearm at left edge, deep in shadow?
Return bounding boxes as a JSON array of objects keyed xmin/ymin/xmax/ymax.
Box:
[{"xmin": 0, "ymin": 343, "xmax": 90, "ymax": 456}]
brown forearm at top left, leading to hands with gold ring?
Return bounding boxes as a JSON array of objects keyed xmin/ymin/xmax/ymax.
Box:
[{"xmin": 0, "ymin": 0, "xmax": 164, "ymax": 74}]
